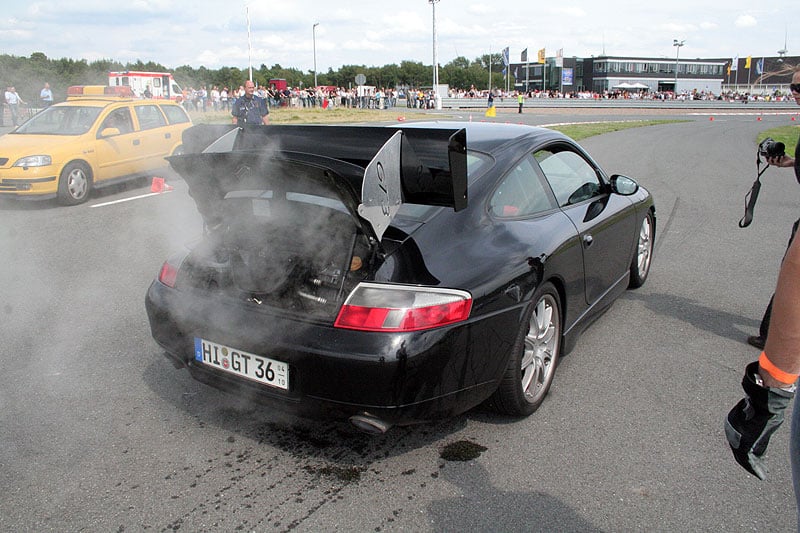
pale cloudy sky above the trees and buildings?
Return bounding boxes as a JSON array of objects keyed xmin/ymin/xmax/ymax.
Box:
[{"xmin": 0, "ymin": 0, "xmax": 800, "ymax": 73}]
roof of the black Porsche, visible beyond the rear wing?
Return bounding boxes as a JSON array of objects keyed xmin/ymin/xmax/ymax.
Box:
[{"xmin": 394, "ymin": 121, "xmax": 569, "ymax": 153}]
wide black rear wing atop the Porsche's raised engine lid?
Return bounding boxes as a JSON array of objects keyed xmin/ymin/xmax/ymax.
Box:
[{"xmin": 183, "ymin": 124, "xmax": 467, "ymax": 213}]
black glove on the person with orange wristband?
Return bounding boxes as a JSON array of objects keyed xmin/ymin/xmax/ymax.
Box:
[{"xmin": 725, "ymin": 361, "xmax": 794, "ymax": 480}]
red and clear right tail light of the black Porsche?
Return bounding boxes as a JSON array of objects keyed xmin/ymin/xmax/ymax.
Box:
[{"xmin": 334, "ymin": 283, "xmax": 472, "ymax": 332}]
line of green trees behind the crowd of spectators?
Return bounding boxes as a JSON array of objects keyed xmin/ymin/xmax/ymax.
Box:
[{"xmin": 0, "ymin": 52, "xmax": 505, "ymax": 104}]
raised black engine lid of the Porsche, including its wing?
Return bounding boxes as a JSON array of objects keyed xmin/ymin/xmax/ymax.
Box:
[{"xmin": 168, "ymin": 125, "xmax": 467, "ymax": 241}]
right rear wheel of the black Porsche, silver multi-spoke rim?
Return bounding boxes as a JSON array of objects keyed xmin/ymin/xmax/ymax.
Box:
[{"xmin": 489, "ymin": 283, "xmax": 562, "ymax": 416}]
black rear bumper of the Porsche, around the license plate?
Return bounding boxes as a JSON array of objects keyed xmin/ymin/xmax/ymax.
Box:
[{"xmin": 145, "ymin": 281, "xmax": 519, "ymax": 424}]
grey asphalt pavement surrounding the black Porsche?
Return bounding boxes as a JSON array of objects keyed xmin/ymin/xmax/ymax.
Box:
[{"xmin": 0, "ymin": 108, "xmax": 800, "ymax": 532}]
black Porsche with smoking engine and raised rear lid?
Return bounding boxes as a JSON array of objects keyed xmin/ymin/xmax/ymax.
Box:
[{"xmin": 146, "ymin": 122, "xmax": 656, "ymax": 432}]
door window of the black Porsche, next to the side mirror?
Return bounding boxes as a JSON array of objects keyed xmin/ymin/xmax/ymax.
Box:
[{"xmin": 534, "ymin": 148, "xmax": 603, "ymax": 207}]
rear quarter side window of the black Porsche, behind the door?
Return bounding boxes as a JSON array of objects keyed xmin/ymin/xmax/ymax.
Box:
[{"xmin": 489, "ymin": 157, "xmax": 555, "ymax": 218}]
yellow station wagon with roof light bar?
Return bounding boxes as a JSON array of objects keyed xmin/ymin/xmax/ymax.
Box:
[{"xmin": 0, "ymin": 86, "xmax": 192, "ymax": 205}]
